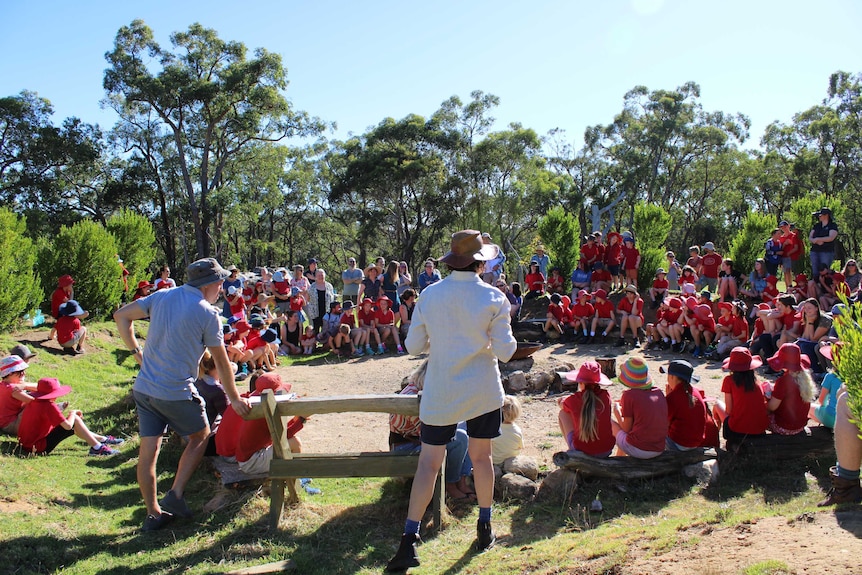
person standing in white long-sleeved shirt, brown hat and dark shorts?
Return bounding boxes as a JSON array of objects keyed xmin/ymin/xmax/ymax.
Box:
[{"xmin": 387, "ymin": 230, "xmax": 517, "ymax": 571}]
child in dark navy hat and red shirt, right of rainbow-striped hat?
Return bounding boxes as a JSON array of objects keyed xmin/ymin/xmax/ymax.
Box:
[{"xmin": 660, "ymin": 359, "xmax": 718, "ymax": 451}]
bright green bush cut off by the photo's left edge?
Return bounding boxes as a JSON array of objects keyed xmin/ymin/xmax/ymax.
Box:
[{"xmin": 0, "ymin": 208, "xmax": 45, "ymax": 329}]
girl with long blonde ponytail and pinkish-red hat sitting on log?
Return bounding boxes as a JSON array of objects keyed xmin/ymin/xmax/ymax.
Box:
[{"xmin": 558, "ymin": 361, "xmax": 616, "ymax": 457}]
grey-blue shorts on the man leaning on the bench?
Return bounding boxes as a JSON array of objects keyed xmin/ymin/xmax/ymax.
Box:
[{"xmin": 132, "ymin": 390, "xmax": 209, "ymax": 437}]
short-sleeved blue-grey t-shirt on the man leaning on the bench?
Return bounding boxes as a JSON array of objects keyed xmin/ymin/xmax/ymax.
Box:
[{"xmin": 133, "ymin": 285, "xmax": 224, "ymax": 401}]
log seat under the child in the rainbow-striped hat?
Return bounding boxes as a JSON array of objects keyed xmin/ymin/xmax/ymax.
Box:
[{"xmin": 554, "ymin": 449, "xmax": 717, "ymax": 481}]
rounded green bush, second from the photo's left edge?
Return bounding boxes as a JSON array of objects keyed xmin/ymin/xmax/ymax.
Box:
[{"xmin": 39, "ymin": 220, "xmax": 123, "ymax": 317}]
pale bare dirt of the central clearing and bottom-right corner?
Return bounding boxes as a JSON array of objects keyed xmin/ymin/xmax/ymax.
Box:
[{"xmin": 280, "ymin": 344, "xmax": 862, "ymax": 575}]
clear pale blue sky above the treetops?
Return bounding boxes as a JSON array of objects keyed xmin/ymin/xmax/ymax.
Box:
[{"xmin": 0, "ymin": 0, "xmax": 862, "ymax": 147}]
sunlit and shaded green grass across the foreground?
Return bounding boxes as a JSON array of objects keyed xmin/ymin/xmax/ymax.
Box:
[{"xmin": 0, "ymin": 323, "xmax": 844, "ymax": 575}]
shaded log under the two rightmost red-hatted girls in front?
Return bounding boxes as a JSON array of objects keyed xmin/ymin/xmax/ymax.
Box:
[{"xmin": 726, "ymin": 426, "xmax": 835, "ymax": 461}]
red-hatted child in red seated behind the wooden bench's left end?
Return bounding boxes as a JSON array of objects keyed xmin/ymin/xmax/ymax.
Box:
[{"xmin": 235, "ymin": 373, "xmax": 307, "ymax": 475}]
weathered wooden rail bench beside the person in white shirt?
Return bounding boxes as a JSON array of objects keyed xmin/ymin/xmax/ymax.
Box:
[{"xmin": 246, "ymin": 390, "xmax": 444, "ymax": 529}]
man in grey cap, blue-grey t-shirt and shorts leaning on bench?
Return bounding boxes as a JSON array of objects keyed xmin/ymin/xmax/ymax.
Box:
[{"xmin": 114, "ymin": 258, "xmax": 249, "ymax": 531}]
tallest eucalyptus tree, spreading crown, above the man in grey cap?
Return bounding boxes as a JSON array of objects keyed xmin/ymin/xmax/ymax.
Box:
[{"xmin": 104, "ymin": 20, "xmax": 321, "ymax": 256}]
